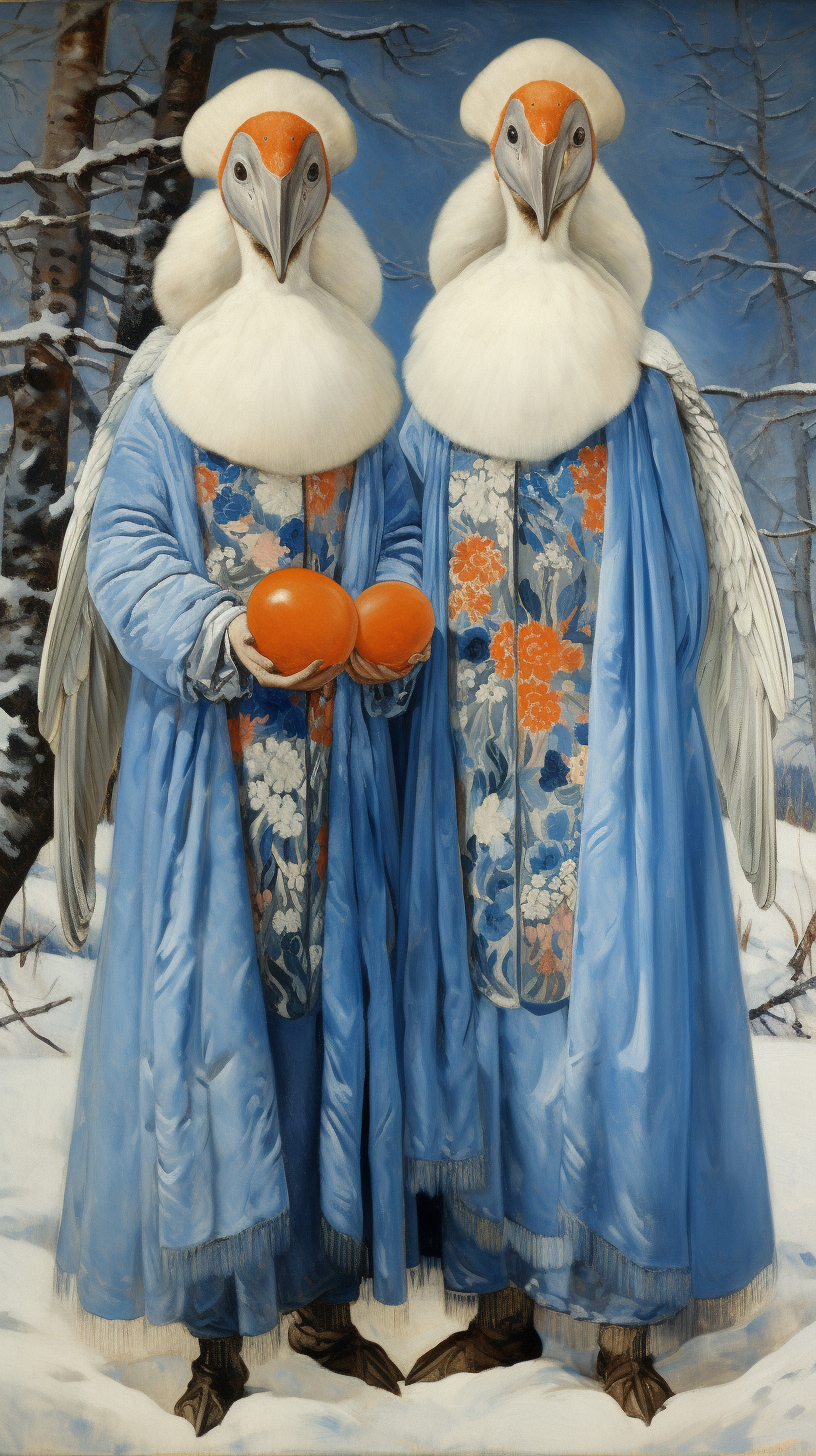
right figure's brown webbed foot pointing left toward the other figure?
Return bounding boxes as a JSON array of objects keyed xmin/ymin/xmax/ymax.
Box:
[{"xmin": 405, "ymin": 1286, "xmax": 541, "ymax": 1385}]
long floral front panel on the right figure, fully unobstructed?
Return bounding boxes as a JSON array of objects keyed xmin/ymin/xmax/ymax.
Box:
[{"xmin": 449, "ymin": 431, "xmax": 606, "ymax": 1006}]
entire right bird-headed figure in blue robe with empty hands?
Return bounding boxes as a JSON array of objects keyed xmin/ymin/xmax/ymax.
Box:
[{"xmin": 401, "ymin": 39, "xmax": 791, "ymax": 1423}]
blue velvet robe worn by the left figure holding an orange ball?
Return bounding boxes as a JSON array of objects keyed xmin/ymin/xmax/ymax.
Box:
[{"xmin": 57, "ymin": 383, "xmax": 421, "ymax": 1335}]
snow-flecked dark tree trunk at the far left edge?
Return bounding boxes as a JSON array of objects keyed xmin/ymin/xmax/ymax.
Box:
[{"xmin": 0, "ymin": 0, "xmax": 108, "ymax": 916}]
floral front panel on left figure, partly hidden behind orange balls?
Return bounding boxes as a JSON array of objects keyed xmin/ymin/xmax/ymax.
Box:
[{"xmin": 195, "ymin": 448, "xmax": 354, "ymax": 1018}]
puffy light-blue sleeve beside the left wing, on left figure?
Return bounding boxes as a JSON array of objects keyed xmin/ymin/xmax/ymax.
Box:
[{"xmin": 87, "ymin": 384, "xmax": 239, "ymax": 700}]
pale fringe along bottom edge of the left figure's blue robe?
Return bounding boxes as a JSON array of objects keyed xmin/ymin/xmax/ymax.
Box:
[{"xmin": 54, "ymin": 1268, "xmax": 281, "ymax": 1366}]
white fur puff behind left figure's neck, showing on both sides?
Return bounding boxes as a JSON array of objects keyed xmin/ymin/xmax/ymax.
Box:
[{"xmin": 153, "ymin": 188, "xmax": 382, "ymax": 329}]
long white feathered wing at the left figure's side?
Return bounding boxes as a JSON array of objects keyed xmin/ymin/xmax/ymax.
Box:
[{"xmin": 38, "ymin": 328, "xmax": 172, "ymax": 951}]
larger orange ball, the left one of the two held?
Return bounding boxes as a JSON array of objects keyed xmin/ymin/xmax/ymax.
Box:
[{"xmin": 246, "ymin": 566, "xmax": 357, "ymax": 677}]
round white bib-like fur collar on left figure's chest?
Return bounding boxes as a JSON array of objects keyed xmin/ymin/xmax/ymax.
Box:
[{"xmin": 153, "ymin": 229, "xmax": 401, "ymax": 476}]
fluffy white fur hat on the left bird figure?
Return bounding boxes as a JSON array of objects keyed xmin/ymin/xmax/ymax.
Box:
[{"xmin": 181, "ymin": 70, "xmax": 357, "ymax": 179}]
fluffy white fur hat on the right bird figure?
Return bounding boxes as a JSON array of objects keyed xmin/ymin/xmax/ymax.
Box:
[{"xmin": 459, "ymin": 39, "xmax": 625, "ymax": 147}]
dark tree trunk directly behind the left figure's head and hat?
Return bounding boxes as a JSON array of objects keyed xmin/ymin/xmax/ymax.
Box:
[{"xmin": 112, "ymin": 0, "xmax": 217, "ymax": 384}]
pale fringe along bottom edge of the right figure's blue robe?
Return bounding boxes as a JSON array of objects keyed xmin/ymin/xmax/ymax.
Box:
[{"xmin": 536, "ymin": 1255, "xmax": 777, "ymax": 1360}]
